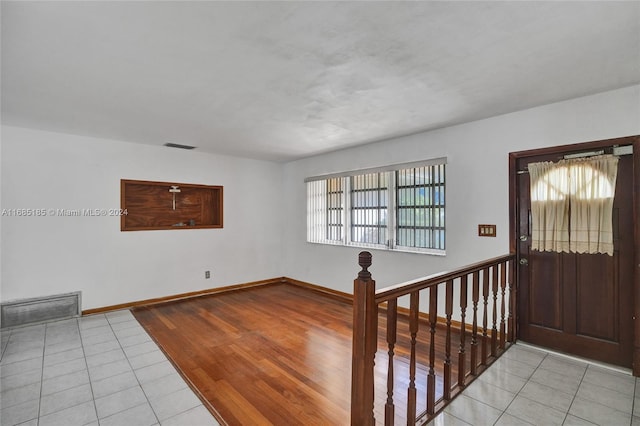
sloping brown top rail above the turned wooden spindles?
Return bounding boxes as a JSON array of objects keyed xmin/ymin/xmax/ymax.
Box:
[{"xmin": 376, "ymin": 254, "xmax": 515, "ymax": 304}]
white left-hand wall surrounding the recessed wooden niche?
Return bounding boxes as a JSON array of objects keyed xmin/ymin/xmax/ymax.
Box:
[{"xmin": 0, "ymin": 126, "xmax": 283, "ymax": 309}]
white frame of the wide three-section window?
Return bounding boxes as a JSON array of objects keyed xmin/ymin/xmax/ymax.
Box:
[{"xmin": 305, "ymin": 158, "xmax": 447, "ymax": 256}]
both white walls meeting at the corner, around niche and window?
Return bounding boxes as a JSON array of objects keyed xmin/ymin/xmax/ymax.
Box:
[{"xmin": 0, "ymin": 86, "xmax": 640, "ymax": 309}]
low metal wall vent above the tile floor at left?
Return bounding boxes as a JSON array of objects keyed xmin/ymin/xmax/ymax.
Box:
[{"xmin": 0, "ymin": 291, "xmax": 82, "ymax": 328}]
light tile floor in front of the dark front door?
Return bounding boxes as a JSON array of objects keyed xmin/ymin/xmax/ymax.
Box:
[{"xmin": 430, "ymin": 344, "xmax": 640, "ymax": 426}]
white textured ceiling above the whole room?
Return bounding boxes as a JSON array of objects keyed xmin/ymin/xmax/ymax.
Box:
[{"xmin": 1, "ymin": 1, "xmax": 640, "ymax": 161}]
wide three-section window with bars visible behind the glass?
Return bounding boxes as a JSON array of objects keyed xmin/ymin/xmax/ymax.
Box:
[{"xmin": 307, "ymin": 159, "xmax": 446, "ymax": 254}]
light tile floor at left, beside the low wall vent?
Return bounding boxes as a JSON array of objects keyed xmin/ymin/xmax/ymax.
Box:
[{"xmin": 0, "ymin": 310, "xmax": 218, "ymax": 426}]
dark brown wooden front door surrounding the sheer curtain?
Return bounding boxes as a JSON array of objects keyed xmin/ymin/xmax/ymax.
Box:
[{"xmin": 515, "ymin": 141, "xmax": 635, "ymax": 368}]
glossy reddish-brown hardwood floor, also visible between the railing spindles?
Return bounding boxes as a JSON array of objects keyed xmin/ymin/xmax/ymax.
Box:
[{"xmin": 132, "ymin": 284, "xmax": 484, "ymax": 425}]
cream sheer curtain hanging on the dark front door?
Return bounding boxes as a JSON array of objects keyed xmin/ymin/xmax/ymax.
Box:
[{"xmin": 529, "ymin": 155, "xmax": 618, "ymax": 256}]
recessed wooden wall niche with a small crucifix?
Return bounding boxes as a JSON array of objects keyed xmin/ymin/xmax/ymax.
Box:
[{"xmin": 120, "ymin": 179, "xmax": 222, "ymax": 231}]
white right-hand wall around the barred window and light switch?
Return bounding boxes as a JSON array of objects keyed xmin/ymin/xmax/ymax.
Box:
[{"xmin": 283, "ymin": 86, "xmax": 640, "ymax": 292}]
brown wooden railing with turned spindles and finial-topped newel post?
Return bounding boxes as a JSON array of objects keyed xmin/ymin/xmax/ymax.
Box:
[{"xmin": 351, "ymin": 252, "xmax": 517, "ymax": 426}]
